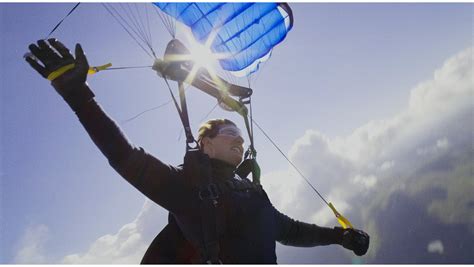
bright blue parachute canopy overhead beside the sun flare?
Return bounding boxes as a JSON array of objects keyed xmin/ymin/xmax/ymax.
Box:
[{"xmin": 154, "ymin": 3, "xmax": 293, "ymax": 75}]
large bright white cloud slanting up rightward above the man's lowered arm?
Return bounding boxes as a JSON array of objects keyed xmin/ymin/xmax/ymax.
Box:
[{"xmin": 269, "ymin": 48, "xmax": 474, "ymax": 224}]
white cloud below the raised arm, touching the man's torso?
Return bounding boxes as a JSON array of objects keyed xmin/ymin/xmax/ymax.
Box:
[{"xmin": 62, "ymin": 200, "xmax": 164, "ymax": 264}]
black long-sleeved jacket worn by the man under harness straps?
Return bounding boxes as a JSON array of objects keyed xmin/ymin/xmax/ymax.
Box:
[{"xmin": 70, "ymin": 88, "xmax": 342, "ymax": 263}]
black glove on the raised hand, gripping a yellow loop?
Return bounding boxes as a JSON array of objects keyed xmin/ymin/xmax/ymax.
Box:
[{"xmin": 25, "ymin": 39, "xmax": 94, "ymax": 111}]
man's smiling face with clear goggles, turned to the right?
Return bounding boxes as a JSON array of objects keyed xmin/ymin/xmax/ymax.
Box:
[{"xmin": 203, "ymin": 125, "xmax": 244, "ymax": 166}]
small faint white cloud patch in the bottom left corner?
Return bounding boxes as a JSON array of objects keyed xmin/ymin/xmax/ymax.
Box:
[{"xmin": 13, "ymin": 224, "xmax": 50, "ymax": 264}]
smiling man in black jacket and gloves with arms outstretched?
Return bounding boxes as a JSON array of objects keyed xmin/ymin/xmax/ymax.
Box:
[{"xmin": 26, "ymin": 39, "xmax": 369, "ymax": 263}]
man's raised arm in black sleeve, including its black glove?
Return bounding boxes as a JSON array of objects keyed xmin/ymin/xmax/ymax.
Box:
[{"xmin": 25, "ymin": 39, "xmax": 188, "ymax": 215}]
